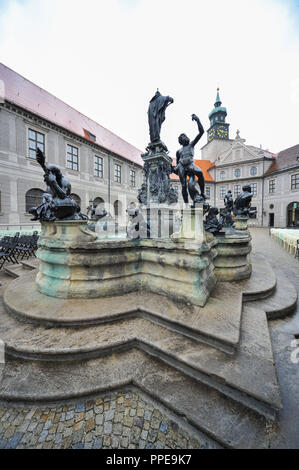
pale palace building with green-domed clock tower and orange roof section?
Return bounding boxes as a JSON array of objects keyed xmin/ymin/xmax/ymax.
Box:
[{"xmin": 172, "ymin": 90, "xmax": 299, "ymax": 227}]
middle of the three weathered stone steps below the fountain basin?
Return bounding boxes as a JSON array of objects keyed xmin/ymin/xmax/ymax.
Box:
[{"xmin": 0, "ymin": 296, "xmax": 281, "ymax": 418}]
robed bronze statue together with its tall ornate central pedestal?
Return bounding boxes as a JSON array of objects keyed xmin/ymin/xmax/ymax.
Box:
[{"xmin": 138, "ymin": 90, "xmax": 178, "ymax": 206}]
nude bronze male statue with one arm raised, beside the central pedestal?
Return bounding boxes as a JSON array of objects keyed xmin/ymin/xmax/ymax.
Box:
[{"xmin": 173, "ymin": 114, "xmax": 206, "ymax": 204}]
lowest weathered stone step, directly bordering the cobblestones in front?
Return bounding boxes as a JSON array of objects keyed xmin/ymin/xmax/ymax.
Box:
[{"xmin": 0, "ymin": 349, "xmax": 271, "ymax": 449}]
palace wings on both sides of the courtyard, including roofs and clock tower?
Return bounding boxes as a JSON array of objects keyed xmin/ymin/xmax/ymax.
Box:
[{"xmin": 0, "ymin": 64, "xmax": 299, "ymax": 230}]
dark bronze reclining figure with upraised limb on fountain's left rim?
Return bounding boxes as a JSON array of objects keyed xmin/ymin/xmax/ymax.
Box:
[{"xmin": 29, "ymin": 148, "xmax": 87, "ymax": 221}]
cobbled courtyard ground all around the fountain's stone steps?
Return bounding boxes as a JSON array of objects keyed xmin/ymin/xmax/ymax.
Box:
[{"xmin": 0, "ymin": 228, "xmax": 299, "ymax": 449}]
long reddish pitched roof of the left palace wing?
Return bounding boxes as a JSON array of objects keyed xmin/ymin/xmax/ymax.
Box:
[{"xmin": 0, "ymin": 63, "xmax": 143, "ymax": 166}]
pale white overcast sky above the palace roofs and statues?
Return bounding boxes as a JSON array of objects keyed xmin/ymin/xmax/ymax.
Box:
[{"xmin": 0, "ymin": 0, "xmax": 299, "ymax": 155}]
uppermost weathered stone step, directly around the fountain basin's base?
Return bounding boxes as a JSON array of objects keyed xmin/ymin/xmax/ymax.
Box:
[{"xmin": 4, "ymin": 253, "xmax": 276, "ymax": 354}]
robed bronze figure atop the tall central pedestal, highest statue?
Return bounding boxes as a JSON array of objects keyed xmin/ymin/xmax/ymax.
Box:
[{"xmin": 147, "ymin": 90, "xmax": 173, "ymax": 143}]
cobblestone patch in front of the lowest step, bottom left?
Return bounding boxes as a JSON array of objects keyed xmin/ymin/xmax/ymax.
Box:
[{"xmin": 0, "ymin": 390, "xmax": 213, "ymax": 449}]
